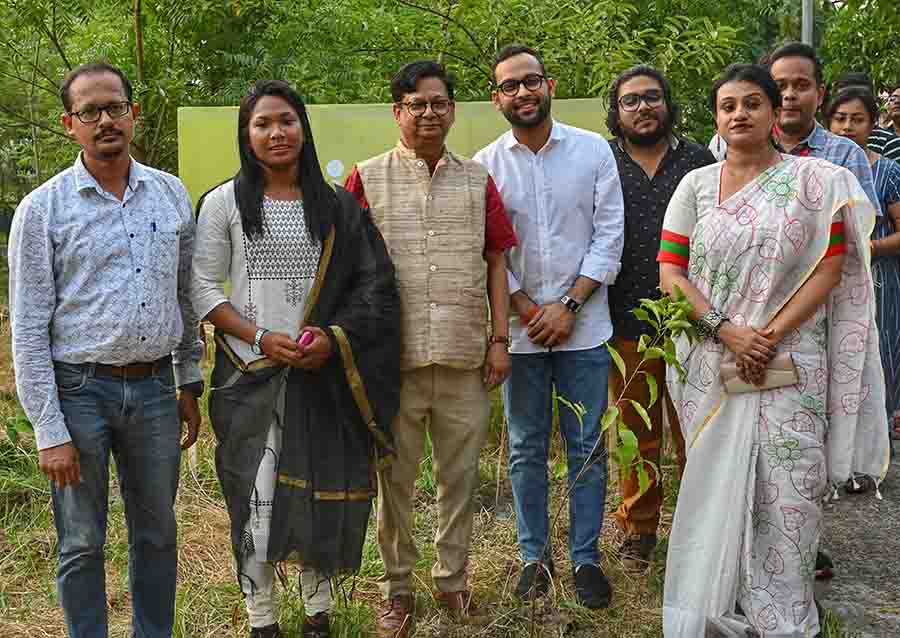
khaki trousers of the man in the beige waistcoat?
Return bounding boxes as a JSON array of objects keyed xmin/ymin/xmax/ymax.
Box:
[{"xmin": 378, "ymin": 365, "xmax": 491, "ymax": 598}]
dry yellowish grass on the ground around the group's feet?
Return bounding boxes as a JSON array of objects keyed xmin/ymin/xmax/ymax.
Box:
[{"xmin": 0, "ymin": 260, "xmax": 842, "ymax": 638}]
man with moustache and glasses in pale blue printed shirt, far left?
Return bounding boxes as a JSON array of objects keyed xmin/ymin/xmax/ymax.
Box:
[{"xmin": 9, "ymin": 64, "xmax": 203, "ymax": 638}]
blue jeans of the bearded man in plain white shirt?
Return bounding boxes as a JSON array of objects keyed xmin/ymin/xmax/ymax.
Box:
[{"xmin": 503, "ymin": 346, "xmax": 611, "ymax": 568}]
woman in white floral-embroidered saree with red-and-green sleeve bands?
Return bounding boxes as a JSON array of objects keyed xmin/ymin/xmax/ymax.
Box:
[{"xmin": 659, "ymin": 65, "xmax": 889, "ymax": 638}]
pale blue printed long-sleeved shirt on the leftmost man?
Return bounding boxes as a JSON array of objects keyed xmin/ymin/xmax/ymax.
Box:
[{"xmin": 9, "ymin": 155, "xmax": 203, "ymax": 450}]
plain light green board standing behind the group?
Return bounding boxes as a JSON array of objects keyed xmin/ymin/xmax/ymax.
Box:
[{"xmin": 178, "ymin": 99, "xmax": 606, "ymax": 202}]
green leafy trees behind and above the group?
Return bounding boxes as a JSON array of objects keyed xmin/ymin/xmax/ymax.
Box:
[{"xmin": 0, "ymin": 0, "xmax": 900, "ymax": 231}]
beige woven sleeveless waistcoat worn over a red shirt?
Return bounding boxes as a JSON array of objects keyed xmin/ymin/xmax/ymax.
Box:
[{"xmin": 357, "ymin": 144, "xmax": 488, "ymax": 370}]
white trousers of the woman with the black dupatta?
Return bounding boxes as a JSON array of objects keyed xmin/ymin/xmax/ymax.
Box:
[{"xmin": 240, "ymin": 423, "xmax": 332, "ymax": 627}]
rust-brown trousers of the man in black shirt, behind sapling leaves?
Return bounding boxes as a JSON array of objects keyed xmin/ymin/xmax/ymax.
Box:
[{"xmin": 609, "ymin": 337, "xmax": 685, "ymax": 534}]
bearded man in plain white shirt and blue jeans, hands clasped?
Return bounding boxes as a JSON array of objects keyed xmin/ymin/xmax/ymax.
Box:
[{"xmin": 475, "ymin": 45, "xmax": 624, "ymax": 608}]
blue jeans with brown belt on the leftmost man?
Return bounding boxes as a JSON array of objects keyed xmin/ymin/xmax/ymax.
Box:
[{"xmin": 52, "ymin": 362, "xmax": 181, "ymax": 638}]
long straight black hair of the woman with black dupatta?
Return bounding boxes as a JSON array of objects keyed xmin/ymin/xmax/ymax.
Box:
[{"xmin": 234, "ymin": 80, "xmax": 339, "ymax": 241}]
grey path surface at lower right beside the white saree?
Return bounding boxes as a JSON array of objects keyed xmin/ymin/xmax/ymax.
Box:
[{"xmin": 818, "ymin": 441, "xmax": 900, "ymax": 638}]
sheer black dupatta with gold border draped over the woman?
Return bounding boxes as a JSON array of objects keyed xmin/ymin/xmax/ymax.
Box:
[{"xmin": 209, "ymin": 188, "xmax": 401, "ymax": 577}]
